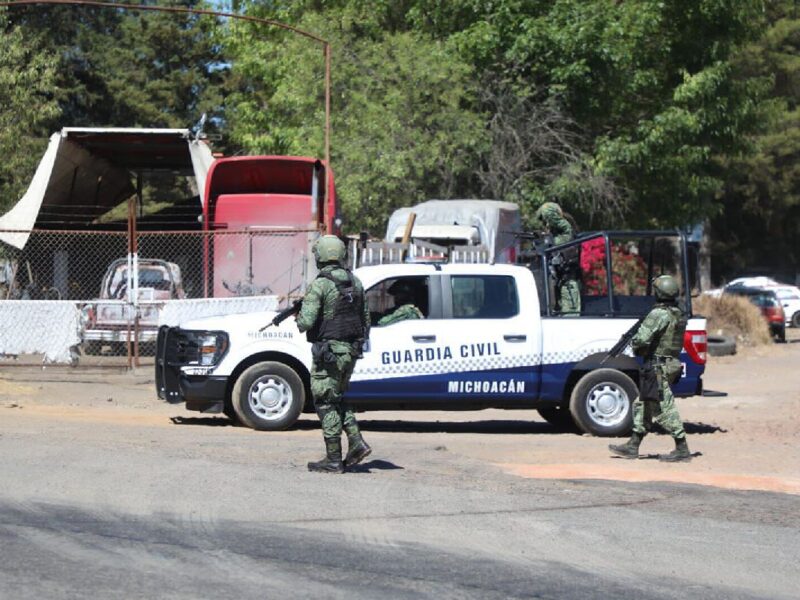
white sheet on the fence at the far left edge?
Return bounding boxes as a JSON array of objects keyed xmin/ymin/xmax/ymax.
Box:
[{"xmin": 0, "ymin": 300, "xmax": 81, "ymax": 363}]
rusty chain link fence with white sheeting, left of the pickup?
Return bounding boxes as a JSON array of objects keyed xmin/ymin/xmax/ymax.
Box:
[{"xmin": 0, "ymin": 227, "xmax": 318, "ymax": 367}]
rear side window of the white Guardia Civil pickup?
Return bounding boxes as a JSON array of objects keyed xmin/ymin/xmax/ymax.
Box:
[{"xmin": 450, "ymin": 275, "xmax": 519, "ymax": 319}]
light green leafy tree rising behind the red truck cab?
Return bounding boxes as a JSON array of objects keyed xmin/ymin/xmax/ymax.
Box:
[{"xmin": 219, "ymin": 5, "xmax": 485, "ymax": 233}]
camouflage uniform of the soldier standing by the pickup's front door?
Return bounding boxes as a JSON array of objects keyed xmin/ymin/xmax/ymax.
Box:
[{"xmin": 297, "ymin": 265, "xmax": 369, "ymax": 440}]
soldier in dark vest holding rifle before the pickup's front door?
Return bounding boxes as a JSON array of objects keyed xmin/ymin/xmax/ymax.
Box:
[{"xmin": 297, "ymin": 235, "xmax": 372, "ymax": 473}]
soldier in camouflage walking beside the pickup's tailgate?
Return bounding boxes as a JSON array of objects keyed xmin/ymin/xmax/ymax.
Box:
[{"xmin": 608, "ymin": 275, "xmax": 692, "ymax": 462}]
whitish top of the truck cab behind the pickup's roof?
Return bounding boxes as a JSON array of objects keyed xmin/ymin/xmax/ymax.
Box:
[{"xmin": 385, "ymin": 200, "xmax": 522, "ymax": 258}]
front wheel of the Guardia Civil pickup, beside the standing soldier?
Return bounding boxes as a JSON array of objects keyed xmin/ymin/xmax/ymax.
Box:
[{"xmin": 231, "ymin": 361, "xmax": 305, "ymax": 431}]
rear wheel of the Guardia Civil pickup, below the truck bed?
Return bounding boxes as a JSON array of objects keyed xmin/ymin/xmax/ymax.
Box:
[{"xmin": 569, "ymin": 369, "xmax": 639, "ymax": 437}]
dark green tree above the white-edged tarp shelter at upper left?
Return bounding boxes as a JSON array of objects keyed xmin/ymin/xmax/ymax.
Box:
[{"xmin": 9, "ymin": 0, "xmax": 225, "ymax": 129}]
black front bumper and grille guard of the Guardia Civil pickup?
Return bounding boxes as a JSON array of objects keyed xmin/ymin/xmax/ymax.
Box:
[{"xmin": 155, "ymin": 325, "xmax": 228, "ymax": 413}]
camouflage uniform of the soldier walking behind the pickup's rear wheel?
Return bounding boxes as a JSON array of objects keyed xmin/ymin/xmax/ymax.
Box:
[{"xmin": 631, "ymin": 304, "xmax": 686, "ymax": 439}]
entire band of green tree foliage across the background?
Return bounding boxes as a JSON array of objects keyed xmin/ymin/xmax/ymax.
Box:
[{"xmin": 0, "ymin": 0, "xmax": 800, "ymax": 278}]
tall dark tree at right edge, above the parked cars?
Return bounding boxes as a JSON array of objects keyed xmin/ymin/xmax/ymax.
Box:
[{"xmin": 712, "ymin": 0, "xmax": 800, "ymax": 280}]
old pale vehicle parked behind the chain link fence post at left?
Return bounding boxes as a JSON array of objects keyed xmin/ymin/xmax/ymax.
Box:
[{"xmin": 82, "ymin": 258, "xmax": 186, "ymax": 354}]
